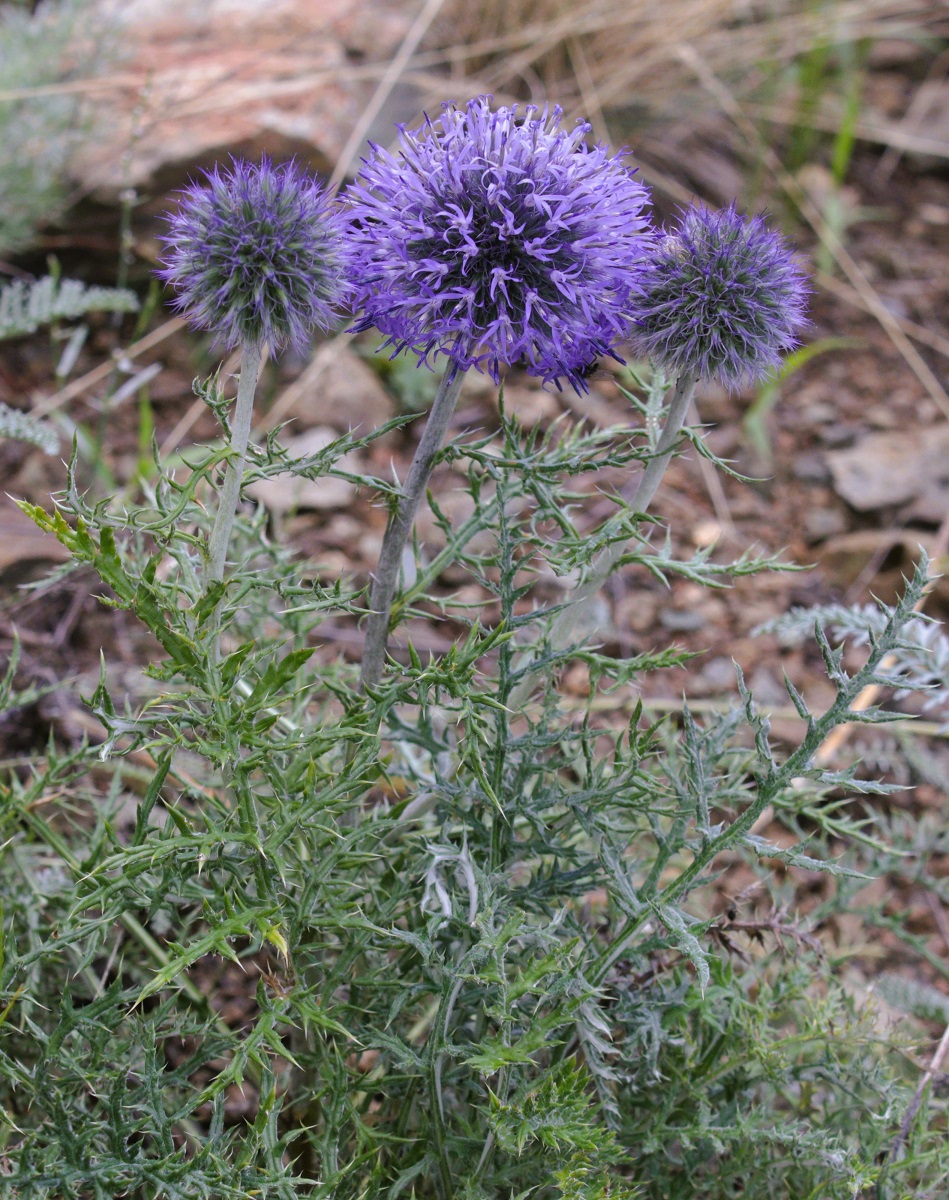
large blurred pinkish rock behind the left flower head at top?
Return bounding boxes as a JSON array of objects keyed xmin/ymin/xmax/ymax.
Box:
[{"xmin": 83, "ymin": 0, "xmax": 420, "ymax": 203}]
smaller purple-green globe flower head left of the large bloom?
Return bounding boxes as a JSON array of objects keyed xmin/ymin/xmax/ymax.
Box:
[{"xmin": 158, "ymin": 157, "xmax": 349, "ymax": 350}]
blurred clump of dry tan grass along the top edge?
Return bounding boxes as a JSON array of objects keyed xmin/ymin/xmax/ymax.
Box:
[{"xmin": 429, "ymin": 0, "xmax": 944, "ymax": 115}]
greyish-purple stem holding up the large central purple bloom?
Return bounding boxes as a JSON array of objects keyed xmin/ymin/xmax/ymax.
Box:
[{"xmin": 360, "ymin": 362, "xmax": 464, "ymax": 690}]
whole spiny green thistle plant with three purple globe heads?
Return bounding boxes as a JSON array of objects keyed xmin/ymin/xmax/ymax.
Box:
[{"xmin": 7, "ymin": 101, "xmax": 949, "ymax": 1200}]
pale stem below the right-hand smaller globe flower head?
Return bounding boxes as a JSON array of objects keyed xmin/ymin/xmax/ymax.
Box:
[{"xmin": 507, "ymin": 373, "xmax": 696, "ymax": 710}]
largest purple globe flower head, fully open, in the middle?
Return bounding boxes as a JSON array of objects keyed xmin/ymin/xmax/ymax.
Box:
[{"xmin": 347, "ymin": 96, "xmax": 648, "ymax": 390}]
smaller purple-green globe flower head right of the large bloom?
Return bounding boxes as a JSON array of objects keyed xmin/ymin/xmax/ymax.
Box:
[{"xmin": 630, "ymin": 204, "xmax": 810, "ymax": 388}]
